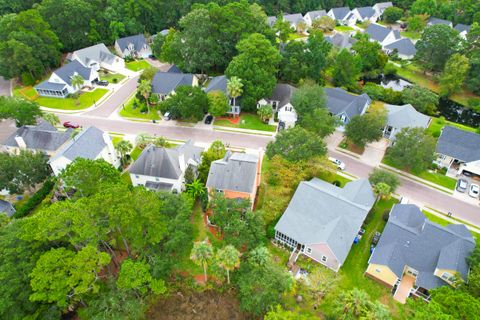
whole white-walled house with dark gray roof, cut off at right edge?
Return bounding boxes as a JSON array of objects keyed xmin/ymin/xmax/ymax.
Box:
[{"xmin": 434, "ymin": 126, "xmax": 480, "ymax": 177}]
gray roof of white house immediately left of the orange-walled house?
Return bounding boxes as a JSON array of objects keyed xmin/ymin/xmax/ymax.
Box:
[{"xmin": 128, "ymin": 141, "xmax": 203, "ymax": 179}]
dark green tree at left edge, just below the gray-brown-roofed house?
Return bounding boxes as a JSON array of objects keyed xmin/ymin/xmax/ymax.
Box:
[{"xmin": 0, "ymin": 150, "xmax": 50, "ymax": 194}]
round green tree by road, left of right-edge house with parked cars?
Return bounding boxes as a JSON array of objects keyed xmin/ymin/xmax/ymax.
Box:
[{"xmin": 387, "ymin": 128, "xmax": 436, "ymax": 172}]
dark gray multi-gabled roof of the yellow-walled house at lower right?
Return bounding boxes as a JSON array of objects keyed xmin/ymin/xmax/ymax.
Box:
[{"xmin": 369, "ymin": 204, "xmax": 475, "ymax": 289}]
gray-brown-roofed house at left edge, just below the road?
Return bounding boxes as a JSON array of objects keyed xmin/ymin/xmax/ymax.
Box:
[{"xmin": 2, "ymin": 120, "xmax": 73, "ymax": 156}]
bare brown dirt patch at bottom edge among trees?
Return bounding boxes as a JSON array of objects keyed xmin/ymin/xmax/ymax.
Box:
[{"xmin": 146, "ymin": 291, "xmax": 248, "ymax": 320}]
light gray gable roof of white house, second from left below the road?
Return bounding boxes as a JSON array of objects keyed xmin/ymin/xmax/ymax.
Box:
[{"xmin": 49, "ymin": 127, "xmax": 107, "ymax": 162}]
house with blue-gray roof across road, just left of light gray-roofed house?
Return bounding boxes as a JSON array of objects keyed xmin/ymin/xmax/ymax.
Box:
[{"xmin": 324, "ymin": 88, "xmax": 372, "ymax": 124}]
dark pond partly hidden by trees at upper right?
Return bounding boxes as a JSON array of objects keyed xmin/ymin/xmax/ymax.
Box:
[{"xmin": 364, "ymin": 75, "xmax": 480, "ymax": 128}]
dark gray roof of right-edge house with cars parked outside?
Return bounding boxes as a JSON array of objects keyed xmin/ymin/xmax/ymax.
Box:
[{"xmin": 437, "ymin": 126, "xmax": 480, "ymax": 162}]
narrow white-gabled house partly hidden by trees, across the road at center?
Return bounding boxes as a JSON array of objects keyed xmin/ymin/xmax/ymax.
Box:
[{"xmin": 257, "ymin": 83, "xmax": 298, "ymax": 129}]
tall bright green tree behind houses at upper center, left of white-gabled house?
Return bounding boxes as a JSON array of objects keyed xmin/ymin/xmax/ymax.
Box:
[{"xmin": 225, "ymin": 33, "xmax": 281, "ymax": 111}]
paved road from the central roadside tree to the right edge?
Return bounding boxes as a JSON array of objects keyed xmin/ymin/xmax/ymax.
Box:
[{"xmin": 329, "ymin": 150, "xmax": 480, "ymax": 226}]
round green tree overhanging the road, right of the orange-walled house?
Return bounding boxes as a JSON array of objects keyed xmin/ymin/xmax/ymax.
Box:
[{"xmin": 265, "ymin": 126, "xmax": 327, "ymax": 162}]
